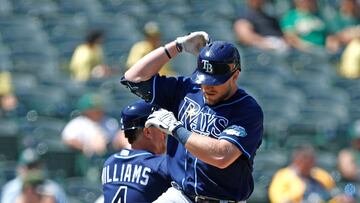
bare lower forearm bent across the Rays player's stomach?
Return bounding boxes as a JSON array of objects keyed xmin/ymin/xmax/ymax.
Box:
[{"xmin": 185, "ymin": 132, "xmax": 241, "ymax": 168}]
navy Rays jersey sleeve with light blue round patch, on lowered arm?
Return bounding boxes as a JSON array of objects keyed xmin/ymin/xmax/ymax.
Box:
[{"xmin": 219, "ymin": 104, "xmax": 263, "ymax": 159}]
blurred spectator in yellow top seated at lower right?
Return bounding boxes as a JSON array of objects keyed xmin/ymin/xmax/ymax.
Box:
[{"xmin": 269, "ymin": 146, "xmax": 354, "ymax": 203}]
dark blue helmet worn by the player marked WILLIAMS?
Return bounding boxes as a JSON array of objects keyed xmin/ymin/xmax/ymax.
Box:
[{"xmin": 121, "ymin": 100, "xmax": 156, "ymax": 130}]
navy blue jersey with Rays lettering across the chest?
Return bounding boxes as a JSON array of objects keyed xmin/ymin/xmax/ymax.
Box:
[{"xmin": 151, "ymin": 75, "xmax": 263, "ymax": 201}]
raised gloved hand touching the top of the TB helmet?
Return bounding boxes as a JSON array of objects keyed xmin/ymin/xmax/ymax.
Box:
[{"xmin": 176, "ymin": 31, "xmax": 209, "ymax": 56}]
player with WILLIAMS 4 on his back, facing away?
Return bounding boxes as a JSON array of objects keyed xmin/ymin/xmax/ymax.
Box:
[{"xmin": 101, "ymin": 101, "xmax": 171, "ymax": 203}]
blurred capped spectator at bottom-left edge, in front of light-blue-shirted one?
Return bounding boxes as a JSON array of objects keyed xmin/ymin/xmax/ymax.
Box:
[{"xmin": 15, "ymin": 171, "xmax": 56, "ymax": 203}]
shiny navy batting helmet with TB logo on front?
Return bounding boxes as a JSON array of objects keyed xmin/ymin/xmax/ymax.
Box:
[{"xmin": 191, "ymin": 41, "xmax": 240, "ymax": 85}]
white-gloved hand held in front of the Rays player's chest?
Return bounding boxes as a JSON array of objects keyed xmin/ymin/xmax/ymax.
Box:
[{"xmin": 145, "ymin": 109, "xmax": 182, "ymax": 135}]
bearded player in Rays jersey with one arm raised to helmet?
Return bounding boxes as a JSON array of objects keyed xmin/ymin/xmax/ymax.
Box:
[{"xmin": 122, "ymin": 32, "xmax": 263, "ymax": 202}]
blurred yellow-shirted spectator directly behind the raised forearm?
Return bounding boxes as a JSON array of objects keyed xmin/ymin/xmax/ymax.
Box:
[{"xmin": 126, "ymin": 21, "xmax": 174, "ymax": 75}]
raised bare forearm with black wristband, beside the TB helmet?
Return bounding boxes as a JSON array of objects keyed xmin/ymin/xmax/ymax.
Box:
[{"xmin": 125, "ymin": 41, "xmax": 178, "ymax": 82}]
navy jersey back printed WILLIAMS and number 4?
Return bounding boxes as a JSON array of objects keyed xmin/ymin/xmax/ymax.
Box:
[{"xmin": 101, "ymin": 149, "xmax": 170, "ymax": 203}]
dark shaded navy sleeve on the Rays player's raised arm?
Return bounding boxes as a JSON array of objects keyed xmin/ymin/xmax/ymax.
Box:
[{"xmin": 151, "ymin": 75, "xmax": 194, "ymax": 112}]
